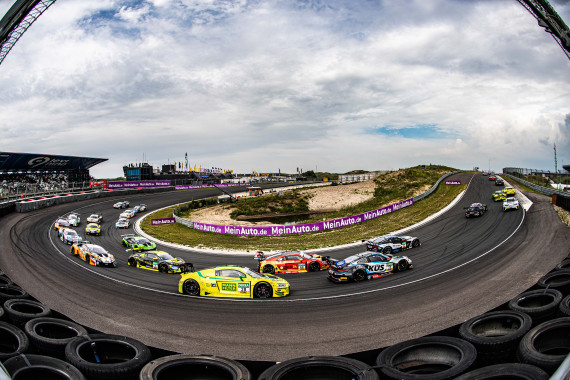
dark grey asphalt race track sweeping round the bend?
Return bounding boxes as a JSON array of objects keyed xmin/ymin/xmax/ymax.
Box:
[{"xmin": 0, "ymin": 173, "xmax": 570, "ymax": 361}]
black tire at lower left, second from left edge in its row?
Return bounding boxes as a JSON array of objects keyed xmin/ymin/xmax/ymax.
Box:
[{"xmin": 24, "ymin": 317, "xmax": 87, "ymax": 359}]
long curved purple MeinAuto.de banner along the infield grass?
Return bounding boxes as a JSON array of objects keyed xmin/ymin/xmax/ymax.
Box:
[{"xmin": 192, "ymin": 198, "xmax": 414, "ymax": 236}]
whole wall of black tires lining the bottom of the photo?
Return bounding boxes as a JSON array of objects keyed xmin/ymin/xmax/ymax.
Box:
[{"xmin": 0, "ymin": 260, "xmax": 570, "ymax": 380}]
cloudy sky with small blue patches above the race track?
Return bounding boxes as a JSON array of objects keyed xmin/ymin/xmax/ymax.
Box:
[{"xmin": 0, "ymin": 0, "xmax": 570, "ymax": 178}]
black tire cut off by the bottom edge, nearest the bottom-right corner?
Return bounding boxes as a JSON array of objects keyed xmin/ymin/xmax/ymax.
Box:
[{"xmin": 455, "ymin": 363, "xmax": 550, "ymax": 380}]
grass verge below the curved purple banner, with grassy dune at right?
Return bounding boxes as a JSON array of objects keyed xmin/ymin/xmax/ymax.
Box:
[{"xmin": 141, "ymin": 165, "xmax": 466, "ymax": 251}]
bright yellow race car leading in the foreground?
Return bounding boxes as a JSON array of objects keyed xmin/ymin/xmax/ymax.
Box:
[{"xmin": 178, "ymin": 265, "xmax": 289, "ymax": 298}]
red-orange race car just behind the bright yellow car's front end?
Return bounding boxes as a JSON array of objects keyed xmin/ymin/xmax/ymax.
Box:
[{"xmin": 254, "ymin": 251, "xmax": 329, "ymax": 274}]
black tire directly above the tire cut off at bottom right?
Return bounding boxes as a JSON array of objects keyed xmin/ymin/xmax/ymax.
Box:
[{"xmin": 459, "ymin": 310, "xmax": 532, "ymax": 365}]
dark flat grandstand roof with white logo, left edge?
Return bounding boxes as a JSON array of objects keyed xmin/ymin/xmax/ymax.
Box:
[{"xmin": 0, "ymin": 152, "xmax": 108, "ymax": 173}]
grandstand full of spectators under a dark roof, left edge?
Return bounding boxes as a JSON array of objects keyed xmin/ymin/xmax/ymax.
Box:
[{"xmin": 0, "ymin": 152, "xmax": 107, "ymax": 199}]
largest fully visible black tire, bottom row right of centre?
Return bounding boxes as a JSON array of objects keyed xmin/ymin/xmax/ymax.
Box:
[{"xmin": 376, "ymin": 336, "xmax": 477, "ymax": 380}]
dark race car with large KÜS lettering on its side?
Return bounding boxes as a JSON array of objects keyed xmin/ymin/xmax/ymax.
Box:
[{"xmin": 328, "ymin": 251, "xmax": 413, "ymax": 283}]
